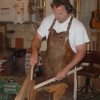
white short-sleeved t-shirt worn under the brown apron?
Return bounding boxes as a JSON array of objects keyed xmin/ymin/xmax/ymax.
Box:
[{"xmin": 37, "ymin": 14, "xmax": 89, "ymax": 52}]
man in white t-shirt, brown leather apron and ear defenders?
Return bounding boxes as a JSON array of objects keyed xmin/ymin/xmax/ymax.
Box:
[{"xmin": 30, "ymin": 0, "xmax": 89, "ymax": 99}]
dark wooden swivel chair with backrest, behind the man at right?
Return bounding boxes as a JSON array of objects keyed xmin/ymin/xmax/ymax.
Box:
[{"xmin": 77, "ymin": 51, "xmax": 100, "ymax": 99}]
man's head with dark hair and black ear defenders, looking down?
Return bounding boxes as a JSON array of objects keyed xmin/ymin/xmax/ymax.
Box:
[{"xmin": 51, "ymin": 0, "xmax": 73, "ymax": 23}]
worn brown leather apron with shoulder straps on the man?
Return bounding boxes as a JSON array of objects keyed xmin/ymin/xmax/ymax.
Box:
[{"xmin": 45, "ymin": 17, "xmax": 74, "ymax": 79}]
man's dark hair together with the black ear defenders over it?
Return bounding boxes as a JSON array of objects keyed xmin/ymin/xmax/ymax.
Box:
[{"xmin": 51, "ymin": 0, "xmax": 73, "ymax": 13}]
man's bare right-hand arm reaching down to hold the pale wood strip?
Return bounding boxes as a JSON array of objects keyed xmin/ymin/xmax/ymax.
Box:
[{"xmin": 55, "ymin": 44, "xmax": 86, "ymax": 81}]
